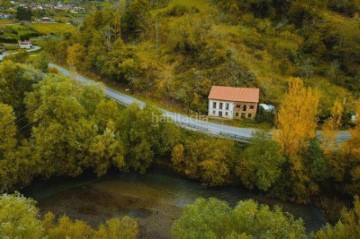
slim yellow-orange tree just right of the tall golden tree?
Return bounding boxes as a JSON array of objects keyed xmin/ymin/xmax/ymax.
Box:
[{"xmin": 321, "ymin": 101, "xmax": 344, "ymax": 155}]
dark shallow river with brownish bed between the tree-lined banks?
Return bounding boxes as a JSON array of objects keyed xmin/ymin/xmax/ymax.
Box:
[{"xmin": 22, "ymin": 170, "xmax": 325, "ymax": 238}]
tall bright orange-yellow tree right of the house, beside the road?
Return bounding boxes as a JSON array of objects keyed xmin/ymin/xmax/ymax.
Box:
[{"xmin": 274, "ymin": 78, "xmax": 320, "ymax": 158}]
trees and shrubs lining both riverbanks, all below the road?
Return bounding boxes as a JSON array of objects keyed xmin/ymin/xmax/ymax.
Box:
[{"xmin": 0, "ymin": 60, "xmax": 360, "ymax": 238}]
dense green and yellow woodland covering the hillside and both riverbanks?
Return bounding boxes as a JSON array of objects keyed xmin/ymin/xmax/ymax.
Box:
[{"xmin": 0, "ymin": 0, "xmax": 360, "ymax": 239}]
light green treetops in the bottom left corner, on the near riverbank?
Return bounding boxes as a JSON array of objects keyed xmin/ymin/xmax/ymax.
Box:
[{"xmin": 0, "ymin": 194, "xmax": 139, "ymax": 239}]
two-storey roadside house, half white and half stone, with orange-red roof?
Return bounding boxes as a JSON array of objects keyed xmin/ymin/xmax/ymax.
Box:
[{"xmin": 209, "ymin": 86, "xmax": 260, "ymax": 119}]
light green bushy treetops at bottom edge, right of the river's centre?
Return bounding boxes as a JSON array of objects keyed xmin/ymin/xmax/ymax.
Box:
[{"xmin": 172, "ymin": 198, "xmax": 306, "ymax": 239}]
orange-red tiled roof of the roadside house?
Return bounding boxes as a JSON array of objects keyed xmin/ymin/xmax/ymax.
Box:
[{"xmin": 209, "ymin": 86, "xmax": 260, "ymax": 103}]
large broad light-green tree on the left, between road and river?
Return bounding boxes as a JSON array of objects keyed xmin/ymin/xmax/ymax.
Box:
[{"xmin": 25, "ymin": 75, "xmax": 125, "ymax": 176}]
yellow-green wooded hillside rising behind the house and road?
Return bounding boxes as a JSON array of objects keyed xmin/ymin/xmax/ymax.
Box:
[{"xmin": 43, "ymin": 0, "xmax": 360, "ymax": 117}]
